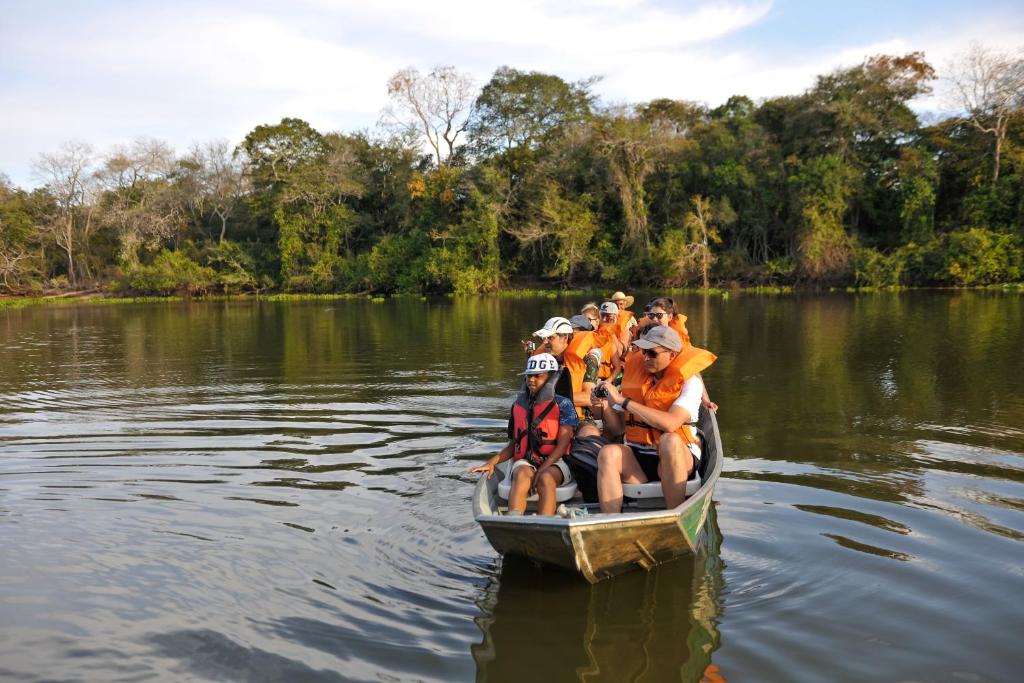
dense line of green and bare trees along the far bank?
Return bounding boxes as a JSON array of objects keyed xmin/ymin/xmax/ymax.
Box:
[{"xmin": 0, "ymin": 46, "xmax": 1024, "ymax": 294}]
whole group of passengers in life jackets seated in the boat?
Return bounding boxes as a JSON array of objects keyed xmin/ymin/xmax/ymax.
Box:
[{"xmin": 470, "ymin": 292, "xmax": 718, "ymax": 515}]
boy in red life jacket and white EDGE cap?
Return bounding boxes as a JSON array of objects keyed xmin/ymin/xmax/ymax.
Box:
[{"xmin": 469, "ymin": 353, "xmax": 579, "ymax": 515}]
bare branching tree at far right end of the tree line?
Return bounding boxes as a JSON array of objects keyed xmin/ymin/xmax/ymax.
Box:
[{"xmin": 949, "ymin": 44, "xmax": 1024, "ymax": 185}]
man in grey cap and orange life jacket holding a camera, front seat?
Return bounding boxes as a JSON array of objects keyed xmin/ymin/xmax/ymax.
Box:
[{"xmin": 595, "ymin": 325, "xmax": 716, "ymax": 512}]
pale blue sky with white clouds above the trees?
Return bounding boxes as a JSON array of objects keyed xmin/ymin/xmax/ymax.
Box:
[{"xmin": 0, "ymin": 0, "xmax": 1024, "ymax": 187}]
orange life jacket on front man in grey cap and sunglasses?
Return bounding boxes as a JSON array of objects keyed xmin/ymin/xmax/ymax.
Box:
[{"xmin": 620, "ymin": 346, "xmax": 717, "ymax": 446}]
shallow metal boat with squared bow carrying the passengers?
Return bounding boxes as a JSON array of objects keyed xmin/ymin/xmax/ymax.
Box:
[{"xmin": 473, "ymin": 410, "xmax": 723, "ymax": 583}]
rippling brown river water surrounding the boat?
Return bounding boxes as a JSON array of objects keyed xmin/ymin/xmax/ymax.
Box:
[{"xmin": 0, "ymin": 292, "xmax": 1024, "ymax": 683}]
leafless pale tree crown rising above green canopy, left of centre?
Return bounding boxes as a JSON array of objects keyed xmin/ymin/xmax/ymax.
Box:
[{"xmin": 383, "ymin": 67, "xmax": 476, "ymax": 166}]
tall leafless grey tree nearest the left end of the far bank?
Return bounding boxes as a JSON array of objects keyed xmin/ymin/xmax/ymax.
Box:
[{"xmin": 33, "ymin": 141, "xmax": 95, "ymax": 287}]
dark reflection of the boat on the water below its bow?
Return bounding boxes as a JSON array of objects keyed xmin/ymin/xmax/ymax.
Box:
[{"xmin": 472, "ymin": 506, "xmax": 724, "ymax": 683}]
